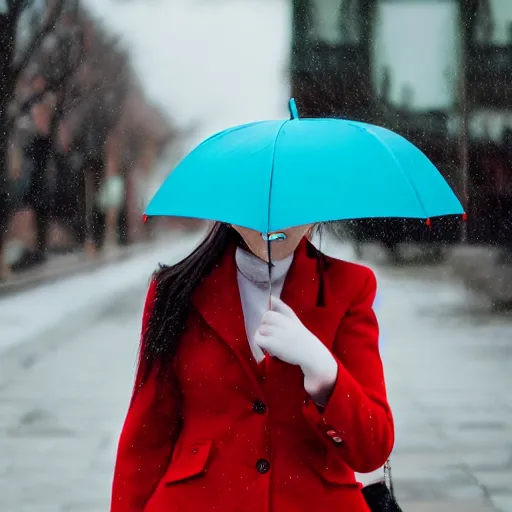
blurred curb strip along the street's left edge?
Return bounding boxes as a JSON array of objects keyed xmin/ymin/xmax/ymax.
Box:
[{"xmin": 0, "ymin": 239, "xmax": 158, "ymax": 298}]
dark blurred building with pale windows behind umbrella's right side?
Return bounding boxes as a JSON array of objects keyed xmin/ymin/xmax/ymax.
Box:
[{"xmin": 292, "ymin": 0, "xmax": 512, "ymax": 244}]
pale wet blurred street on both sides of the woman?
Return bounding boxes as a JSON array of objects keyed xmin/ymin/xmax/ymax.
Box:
[{"xmin": 0, "ymin": 237, "xmax": 512, "ymax": 512}]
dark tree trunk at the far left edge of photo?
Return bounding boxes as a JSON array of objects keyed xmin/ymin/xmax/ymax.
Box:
[{"xmin": 0, "ymin": 15, "xmax": 16, "ymax": 280}]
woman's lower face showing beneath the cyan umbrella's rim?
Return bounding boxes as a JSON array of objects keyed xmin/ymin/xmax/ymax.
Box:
[{"xmin": 233, "ymin": 224, "xmax": 313, "ymax": 261}]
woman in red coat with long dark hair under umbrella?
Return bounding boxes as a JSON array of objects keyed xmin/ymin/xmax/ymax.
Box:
[{"xmin": 111, "ymin": 224, "xmax": 394, "ymax": 512}]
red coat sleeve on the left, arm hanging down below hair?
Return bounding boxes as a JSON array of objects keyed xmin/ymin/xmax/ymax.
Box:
[{"xmin": 110, "ymin": 281, "xmax": 179, "ymax": 512}]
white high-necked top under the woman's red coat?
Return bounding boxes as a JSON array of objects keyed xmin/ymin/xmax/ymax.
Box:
[{"xmin": 235, "ymin": 247, "xmax": 293, "ymax": 363}]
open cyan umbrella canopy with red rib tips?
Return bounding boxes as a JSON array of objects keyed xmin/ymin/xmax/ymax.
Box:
[{"xmin": 146, "ymin": 99, "xmax": 464, "ymax": 233}]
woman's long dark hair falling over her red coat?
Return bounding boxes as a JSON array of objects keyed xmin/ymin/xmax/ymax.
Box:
[{"xmin": 140, "ymin": 223, "xmax": 325, "ymax": 380}]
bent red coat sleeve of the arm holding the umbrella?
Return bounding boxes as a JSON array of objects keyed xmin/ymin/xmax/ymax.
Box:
[{"xmin": 304, "ymin": 269, "xmax": 394, "ymax": 473}]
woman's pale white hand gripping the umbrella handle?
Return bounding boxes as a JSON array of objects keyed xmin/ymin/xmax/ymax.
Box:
[{"xmin": 254, "ymin": 297, "xmax": 338, "ymax": 406}]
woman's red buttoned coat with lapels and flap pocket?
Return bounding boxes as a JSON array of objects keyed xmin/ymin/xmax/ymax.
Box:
[{"xmin": 111, "ymin": 243, "xmax": 394, "ymax": 512}]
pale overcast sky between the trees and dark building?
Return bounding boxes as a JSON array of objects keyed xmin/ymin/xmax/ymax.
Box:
[{"xmin": 85, "ymin": 0, "xmax": 291, "ymax": 146}]
